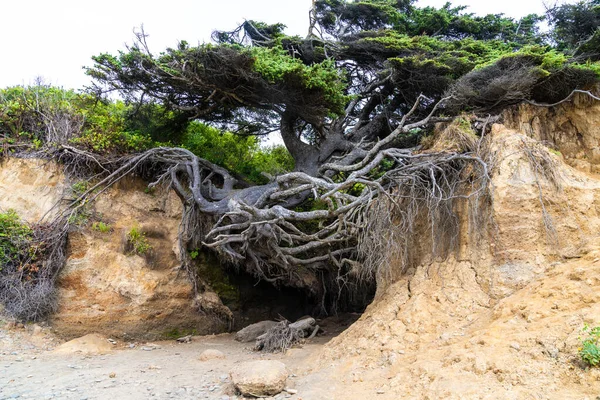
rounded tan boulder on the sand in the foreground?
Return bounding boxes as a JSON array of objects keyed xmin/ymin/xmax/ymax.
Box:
[{"xmin": 229, "ymin": 360, "xmax": 288, "ymax": 397}]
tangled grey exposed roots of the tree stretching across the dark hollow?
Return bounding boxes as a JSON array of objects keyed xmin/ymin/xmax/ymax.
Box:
[{"xmin": 0, "ymin": 97, "xmax": 489, "ymax": 318}]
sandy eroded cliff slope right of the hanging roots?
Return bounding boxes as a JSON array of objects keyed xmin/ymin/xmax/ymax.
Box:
[{"xmin": 315, "ymin": 99, "xmax": 600, "ymax": 399}]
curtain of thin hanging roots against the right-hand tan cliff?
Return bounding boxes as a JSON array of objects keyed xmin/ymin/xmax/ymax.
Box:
[{"xmin": 354, "ymin": 124, "xmax": 494, "ymax": 282}]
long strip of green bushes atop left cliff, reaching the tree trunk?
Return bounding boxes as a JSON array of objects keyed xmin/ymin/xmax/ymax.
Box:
[{"xmin": 0, "ymin": 85, "xmax": 296, "ymax": 178}]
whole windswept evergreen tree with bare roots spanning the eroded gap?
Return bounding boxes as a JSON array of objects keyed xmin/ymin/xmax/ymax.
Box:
[{"xmin": 79, "ymin": 0, "xmax": 597, "ymax": 310}]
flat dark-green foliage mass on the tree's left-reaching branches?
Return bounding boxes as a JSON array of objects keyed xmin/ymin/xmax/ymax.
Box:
[{"xmin": 86, "ymin": 42, "xmax": 344, "ymax": 128}]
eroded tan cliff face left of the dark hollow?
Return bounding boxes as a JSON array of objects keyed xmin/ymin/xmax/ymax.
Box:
[{"xmin": 0, "ymin": 159, "xmax": 227, "ymax": 339}]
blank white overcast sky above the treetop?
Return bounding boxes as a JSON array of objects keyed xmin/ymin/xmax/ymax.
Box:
[{"xmin": 0, "ymin": 0, "xmax": 572, "ymax": 88}]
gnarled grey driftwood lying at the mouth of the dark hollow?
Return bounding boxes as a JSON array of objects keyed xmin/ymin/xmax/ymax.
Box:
[{"xmin": 254, "ymin": 318, "xmax": 319, "ymax": 353}]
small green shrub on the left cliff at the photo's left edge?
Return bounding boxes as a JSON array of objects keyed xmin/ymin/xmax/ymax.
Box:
[{"xmin": 0, "ymin": 209, "xmax": 35, "ymax": 271}]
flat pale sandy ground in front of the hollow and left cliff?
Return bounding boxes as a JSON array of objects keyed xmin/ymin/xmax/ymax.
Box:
[{"xmin": 0, "ymin": 322, "xmax": 354, "ymax": 400}]
